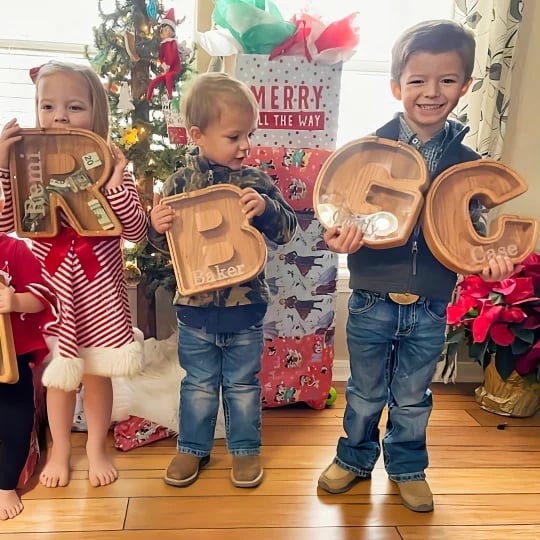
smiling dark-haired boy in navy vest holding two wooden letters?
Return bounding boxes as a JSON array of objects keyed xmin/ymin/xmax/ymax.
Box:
[{"xmin": 319, "ymin": 20, "xmax": 513, "ymax": 512}]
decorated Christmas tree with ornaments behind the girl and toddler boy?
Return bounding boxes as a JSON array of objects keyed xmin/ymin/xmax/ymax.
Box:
[{"xmin": 87, "ymin": 0, "xmax": 194, "ymax": 336}]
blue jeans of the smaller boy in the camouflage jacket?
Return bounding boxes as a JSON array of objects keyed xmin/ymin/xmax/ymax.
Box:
[{"xmin": 177, "ymin": 322, "xmax": 263, "ymax": 457}]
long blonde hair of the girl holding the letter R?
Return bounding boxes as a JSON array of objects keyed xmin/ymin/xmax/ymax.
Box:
[{"xmin": 35, "ymin": 60, "xmax": 109, "ymax": 140}]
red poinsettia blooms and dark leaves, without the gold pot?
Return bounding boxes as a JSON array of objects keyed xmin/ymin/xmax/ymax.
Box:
[{"xmin": 447, "ymin": 253, "xmax": 540, "ymax": 381}]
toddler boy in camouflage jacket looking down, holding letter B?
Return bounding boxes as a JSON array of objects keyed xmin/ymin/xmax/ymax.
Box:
[{"xmin": 149, "ymin": 73, "xmax": 296, "ymax": 488}]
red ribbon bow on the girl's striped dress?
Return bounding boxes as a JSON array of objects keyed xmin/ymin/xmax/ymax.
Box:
[{"xmin": 45, "ymin": 227, "xmax": 105, "ymax": 281}]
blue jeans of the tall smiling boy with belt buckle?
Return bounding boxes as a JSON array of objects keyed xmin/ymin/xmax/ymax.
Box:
[{"xmin": 335, "ymin": 290, "xmax": 447, "ymax": 482}]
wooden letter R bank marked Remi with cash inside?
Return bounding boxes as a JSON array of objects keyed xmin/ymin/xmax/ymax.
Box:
[{"xmin": 10, "ymin": 129, "xmax": 121, "ymax": 238}]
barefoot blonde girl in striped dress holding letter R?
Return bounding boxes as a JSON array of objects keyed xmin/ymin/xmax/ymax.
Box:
[{"xmin": 0, "ymin": 62, "xmax": 146, "ymax": 487}]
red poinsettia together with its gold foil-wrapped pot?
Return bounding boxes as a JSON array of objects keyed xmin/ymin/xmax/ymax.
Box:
[{"xmin": 447, "ymin": 253, "xmax": 540, "ymax": 416}]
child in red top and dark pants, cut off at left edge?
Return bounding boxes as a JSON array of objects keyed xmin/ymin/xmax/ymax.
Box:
[{"xmin": 0, "ymin": 182, "xmax": 57, "ymax": 520}]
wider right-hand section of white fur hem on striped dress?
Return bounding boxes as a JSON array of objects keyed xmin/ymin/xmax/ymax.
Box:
[{"xmin": 79, "ymin": 328, "xmax": 144, "ymax": 377}]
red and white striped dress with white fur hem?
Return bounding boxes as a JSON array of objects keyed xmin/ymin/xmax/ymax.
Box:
[{"xmin": 0, "ymin": 169, "xmax": 147, "ymax": 390}]
